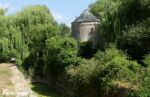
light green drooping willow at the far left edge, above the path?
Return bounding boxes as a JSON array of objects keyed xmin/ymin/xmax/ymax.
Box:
[{"xmin": 0, "ymin": 10, "xmax": 23, "ymax": 64}]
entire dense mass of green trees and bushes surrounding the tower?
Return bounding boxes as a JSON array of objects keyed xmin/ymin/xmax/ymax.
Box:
[{"xmin": 0, "ymin": 0, "xmax": 150, "ymax": 97}]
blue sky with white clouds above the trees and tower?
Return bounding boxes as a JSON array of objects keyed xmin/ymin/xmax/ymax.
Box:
[{"xmin": 0, "ymin": 0, "xmax": 96, "ymax": 26}]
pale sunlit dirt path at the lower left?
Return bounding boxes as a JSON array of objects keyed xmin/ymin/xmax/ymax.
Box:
[{"xmin": 3, "ymin": 64, "xmax": 36, "ymax": 97}]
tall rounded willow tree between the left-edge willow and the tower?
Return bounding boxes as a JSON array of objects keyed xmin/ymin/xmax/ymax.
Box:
[{"xmin": 15, "ymin": 5, "xmax": 58, "ymax": 74}]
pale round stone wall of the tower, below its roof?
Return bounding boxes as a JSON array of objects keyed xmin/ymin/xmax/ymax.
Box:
[{"xmin": 72, "ymin": 22, "xmax": 104, "ymax": 48}]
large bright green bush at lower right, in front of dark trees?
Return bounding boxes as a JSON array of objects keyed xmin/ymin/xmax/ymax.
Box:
[{"xmin": 95, "ymin": 48, "xmax": 140, "ymax": 87}]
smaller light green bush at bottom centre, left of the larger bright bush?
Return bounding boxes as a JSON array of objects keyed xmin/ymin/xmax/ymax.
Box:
[{"xmin": 66, "ymin": 59, "xmax": 96, "ymax": 85}]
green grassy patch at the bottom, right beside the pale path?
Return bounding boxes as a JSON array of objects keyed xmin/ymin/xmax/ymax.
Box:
[{"xmin": 30, "ymin": 82, "xmax": 62, "ymax": 97}]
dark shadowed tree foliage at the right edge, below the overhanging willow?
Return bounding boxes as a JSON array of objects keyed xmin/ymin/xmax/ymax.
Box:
[{"xmin": 118, "ymin": 18, "xmax": 150, "ymax": 59}]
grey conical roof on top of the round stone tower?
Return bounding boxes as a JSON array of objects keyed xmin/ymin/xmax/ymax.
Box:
[{"xmin": 73, "ymin": 10, "xmax": 100, "ymax": 23}]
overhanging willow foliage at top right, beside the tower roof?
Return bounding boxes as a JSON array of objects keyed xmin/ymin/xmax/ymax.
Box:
[{"xmin": 90, "ymin": 0, "xmax": 150, "ymax": 42}]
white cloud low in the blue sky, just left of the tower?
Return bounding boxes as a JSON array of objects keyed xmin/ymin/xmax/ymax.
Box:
[{"xmin": 52, "ymin": 11, "xmax": 70, "ymax": 26}]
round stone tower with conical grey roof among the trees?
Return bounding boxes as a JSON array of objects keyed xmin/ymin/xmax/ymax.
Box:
[{"xmin": 71, "ymin": 10, "xmax": 100, "ymax": 47}]
